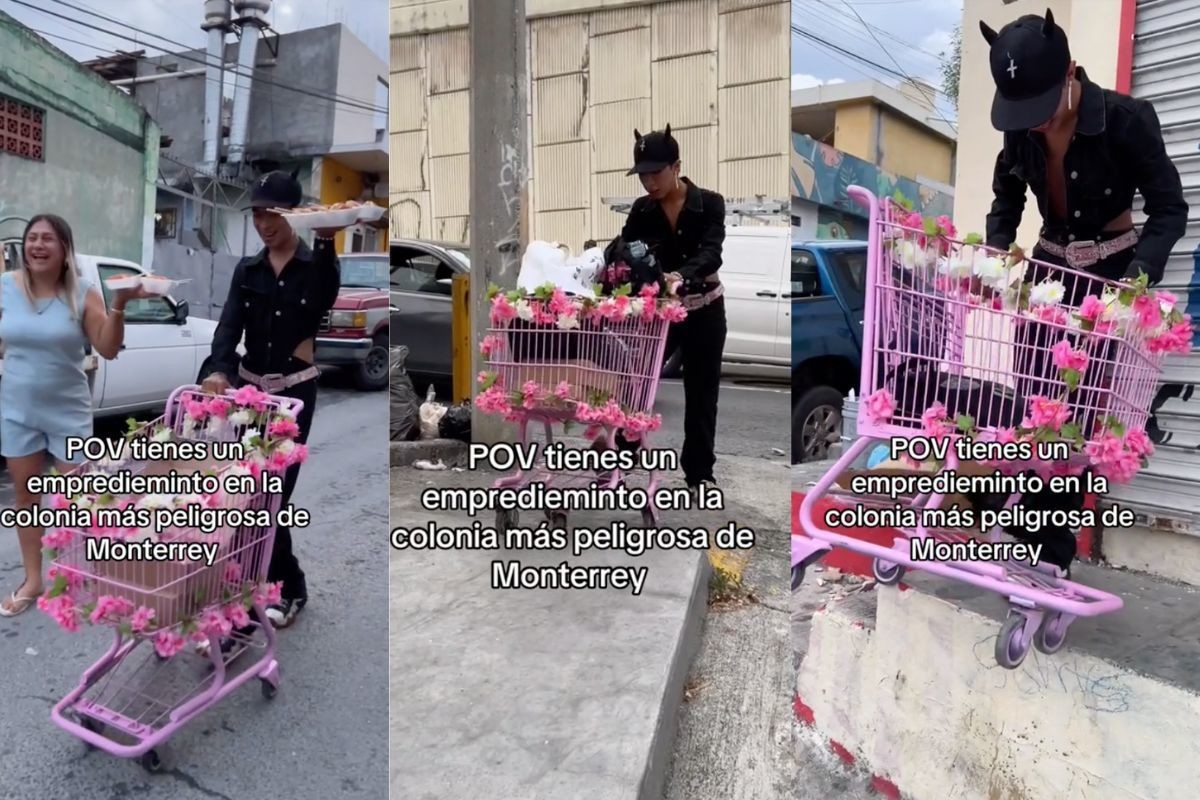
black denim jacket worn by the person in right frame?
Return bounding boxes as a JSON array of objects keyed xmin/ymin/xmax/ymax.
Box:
[{"xmin": 986, "ymin": 67, "xmax": 1188, "ymax": 283}]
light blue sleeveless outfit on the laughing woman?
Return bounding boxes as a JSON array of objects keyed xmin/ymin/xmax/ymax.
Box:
[{"xmin": 0, "ymin": 272, "xmax": 92, "ymax": 463}]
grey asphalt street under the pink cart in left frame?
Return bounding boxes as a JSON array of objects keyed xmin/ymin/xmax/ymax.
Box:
[{"xmin": 0, "ymin": 374, "xmax": 388, "ymax": 800}]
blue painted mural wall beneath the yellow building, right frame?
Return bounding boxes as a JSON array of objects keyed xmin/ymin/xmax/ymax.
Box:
[{"xmin": 792, "ymin": 133, "xmax": 954, "ymax": 221}]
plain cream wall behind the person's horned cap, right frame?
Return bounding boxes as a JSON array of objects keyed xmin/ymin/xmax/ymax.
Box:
[{"xmin": 954, "ymin": 0, "xmax": 1121, "ymax": 249}]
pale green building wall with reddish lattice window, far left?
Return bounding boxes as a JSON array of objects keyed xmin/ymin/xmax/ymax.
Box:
[{"xmin": 0, "ymin": 13, "xmax": 158, "ymax": 263}]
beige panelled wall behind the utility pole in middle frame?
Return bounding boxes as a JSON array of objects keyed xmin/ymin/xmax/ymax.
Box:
[{"xmin": 390, "ymin": 0, "xmax": 791, "ymax": 249}]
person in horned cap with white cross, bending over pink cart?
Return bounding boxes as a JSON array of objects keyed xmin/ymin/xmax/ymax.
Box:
[{"xmin": 979, "ymin": 10, "xmax": 1188, "ymax": 570}]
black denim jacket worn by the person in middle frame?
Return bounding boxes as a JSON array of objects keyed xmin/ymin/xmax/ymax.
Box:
[{"xmin": 620, "ymin": 178, "xmax": 725, "ymax": 281}]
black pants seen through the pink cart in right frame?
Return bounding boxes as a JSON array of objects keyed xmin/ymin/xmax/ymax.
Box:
[{"xmin": 993, "ymin": 235, "xmax": 1134, "ymax": 570}]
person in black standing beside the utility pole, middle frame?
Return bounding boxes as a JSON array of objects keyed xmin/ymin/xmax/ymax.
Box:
[{"xmin": 620, "ymin": 125, "xmax": 726, "ymax": 489}]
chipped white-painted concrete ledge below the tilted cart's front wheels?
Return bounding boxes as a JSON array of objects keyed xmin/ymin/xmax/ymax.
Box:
[{"xmin": 794, "ymin": 588, "xmax": 1200, "ymax": 800}]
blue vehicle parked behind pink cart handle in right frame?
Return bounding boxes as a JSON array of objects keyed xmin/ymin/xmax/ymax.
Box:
[{"xmin": 790, "ymin": 240, "xmax": 866, "ymax": 463}]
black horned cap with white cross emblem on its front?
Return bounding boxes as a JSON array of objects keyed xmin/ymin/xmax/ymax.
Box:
[{"xmin": 979, "ymin": 8, "xmax": 1070, "ymax": 131}]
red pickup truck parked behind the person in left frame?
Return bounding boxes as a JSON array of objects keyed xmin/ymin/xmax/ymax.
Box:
[{"xmin": 316, "ymin": 253, "xmax": 390, "ymax": 391}]
